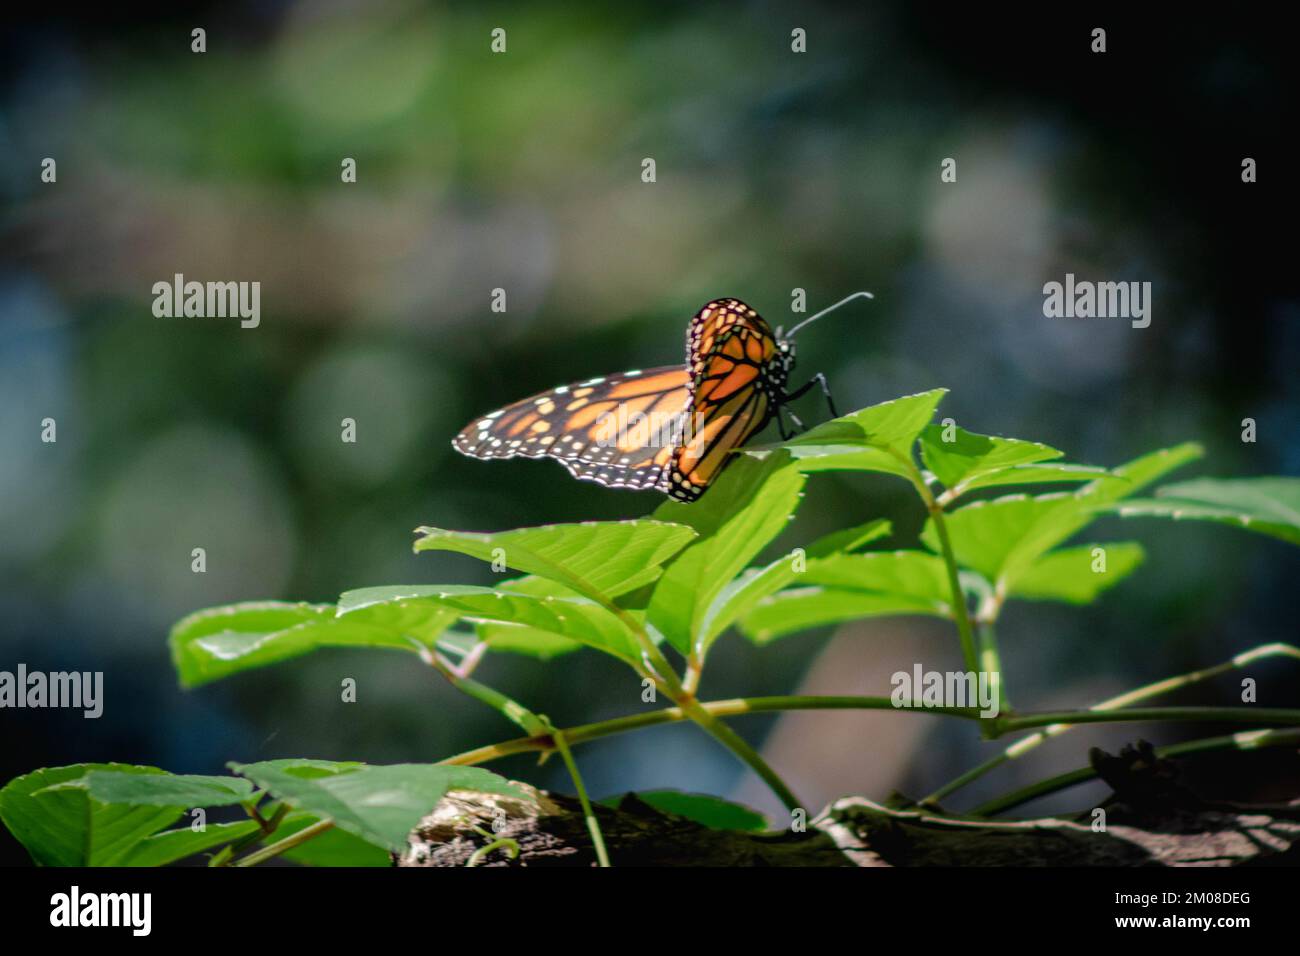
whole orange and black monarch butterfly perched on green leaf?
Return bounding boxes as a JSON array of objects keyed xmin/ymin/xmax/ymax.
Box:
[{"xmin": 451, "ymin": 293, "xmax": 872, "ymax": 501}]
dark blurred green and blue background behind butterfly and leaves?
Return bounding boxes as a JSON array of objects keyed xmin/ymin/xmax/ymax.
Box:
[{"xmin": 0, "ymin": 3, "xmax": 1300, "ymax": 862}]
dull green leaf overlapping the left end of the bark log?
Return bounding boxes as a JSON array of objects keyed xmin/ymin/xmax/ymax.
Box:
[{"xmin": 230, "ymin": 761, "xmax": 532, "ymax": 852}]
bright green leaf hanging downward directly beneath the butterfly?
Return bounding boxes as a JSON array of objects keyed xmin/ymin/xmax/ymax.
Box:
[{"xmin": 646, "ymin": 453, "xmax": 805, "ymax": 654}]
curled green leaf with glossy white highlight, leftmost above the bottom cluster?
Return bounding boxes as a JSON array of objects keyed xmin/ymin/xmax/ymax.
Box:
[{"xmin": 169, "ymin": 601, "xmax": 456, "ymax": 687}]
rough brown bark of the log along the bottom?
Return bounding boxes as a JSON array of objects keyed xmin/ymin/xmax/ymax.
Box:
[{"xmin": 395, "ymin": 745, "xmax": 1300, "ymax": 866}]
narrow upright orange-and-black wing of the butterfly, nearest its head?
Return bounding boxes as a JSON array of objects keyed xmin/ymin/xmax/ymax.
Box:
[{"xmin": 667, "ymin": 299, "xmax": 780, "ymax": 501}]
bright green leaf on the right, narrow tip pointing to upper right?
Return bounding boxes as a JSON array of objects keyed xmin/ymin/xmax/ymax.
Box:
[{"xmin": 920, "ymin": 444, "xmax": 1201, "ymax": 591}]
